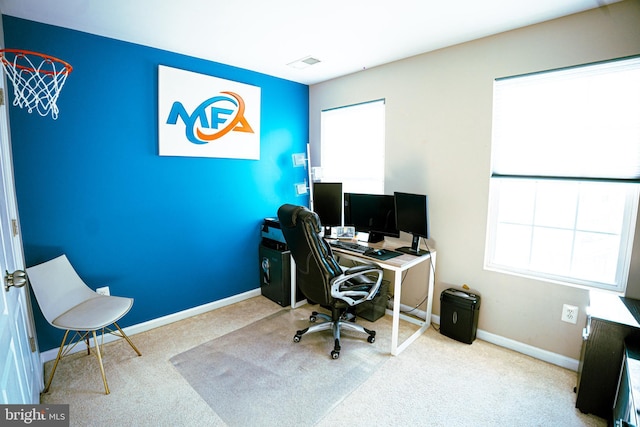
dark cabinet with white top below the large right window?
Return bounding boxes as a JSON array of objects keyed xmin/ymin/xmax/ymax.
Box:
[{"xmin": 576, "ymin": 292, "xmax": 640, "ymax": 420}]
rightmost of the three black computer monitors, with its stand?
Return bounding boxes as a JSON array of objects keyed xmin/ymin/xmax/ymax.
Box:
[{"xmin": 393, "ymin": 192, "xmax": 431, "ymax": 256}]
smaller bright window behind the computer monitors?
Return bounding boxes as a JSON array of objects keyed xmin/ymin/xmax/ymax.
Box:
[{"xmin": 320, "ymin": 100, "xmax": 385, "ymax": 194}]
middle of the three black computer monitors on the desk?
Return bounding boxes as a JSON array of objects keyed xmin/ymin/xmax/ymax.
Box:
[{"xmin": 344, "ymin": 193, "xmax": 400, "ymax": 243}]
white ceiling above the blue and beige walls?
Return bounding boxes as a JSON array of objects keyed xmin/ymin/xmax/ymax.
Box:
[{"xmin": 0, "ymin": 0, "xmax": 620, "ymax": 84}]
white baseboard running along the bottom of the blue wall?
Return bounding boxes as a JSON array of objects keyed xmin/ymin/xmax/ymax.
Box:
[{"xmin": 40, "ymin": 288, "xmax": 261, "ymax": 365}]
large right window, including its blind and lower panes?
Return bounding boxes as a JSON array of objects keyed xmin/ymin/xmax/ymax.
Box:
[{"xmin": 485, "ymin": 57, "xmax": 640, "ymax": 292}]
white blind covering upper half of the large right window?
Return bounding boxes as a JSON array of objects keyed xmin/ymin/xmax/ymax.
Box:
[{"xmin": 492, "ymin": 57, "xmax": 640, "ymax": 180}]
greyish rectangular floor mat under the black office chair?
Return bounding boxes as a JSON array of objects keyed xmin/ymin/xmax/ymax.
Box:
[{"xmin": 171, "ymin": 309, "xmax": 391, "ymax": 426}]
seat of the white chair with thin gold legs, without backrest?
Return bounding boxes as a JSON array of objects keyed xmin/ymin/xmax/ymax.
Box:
[{"xmin": 51, "ymin": 295, "xmax": 133, "ymax": 331}]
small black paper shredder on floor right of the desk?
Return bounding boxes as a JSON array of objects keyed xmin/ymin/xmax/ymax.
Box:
[{"xmin": 440, "ymin": 288, "xmax": 480, "ymax": 344}]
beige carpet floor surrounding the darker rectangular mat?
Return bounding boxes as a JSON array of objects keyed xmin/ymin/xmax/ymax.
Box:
[{"xmin": 42, "ymin": 297, "xmax": 606, "ymax": 427}]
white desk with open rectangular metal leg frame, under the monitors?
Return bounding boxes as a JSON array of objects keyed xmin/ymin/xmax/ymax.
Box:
[{"xmin": 291, "ymin": 237, "xmax": 436, "ymax": 356}]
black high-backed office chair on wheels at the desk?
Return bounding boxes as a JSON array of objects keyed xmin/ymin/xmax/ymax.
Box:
[{"xmin": 278, "ymin": 204, "xmax": 382, "ymax": 359}]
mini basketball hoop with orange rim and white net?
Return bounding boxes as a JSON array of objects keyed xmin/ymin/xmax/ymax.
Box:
[{"xmin": 0, "ymin": 49, "xmax": 72, "ymax": 120}]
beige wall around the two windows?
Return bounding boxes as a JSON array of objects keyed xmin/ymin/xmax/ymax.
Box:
[{"xmin": 309, "ymin": 0, "xmax": 640, "ymax": 359}]
